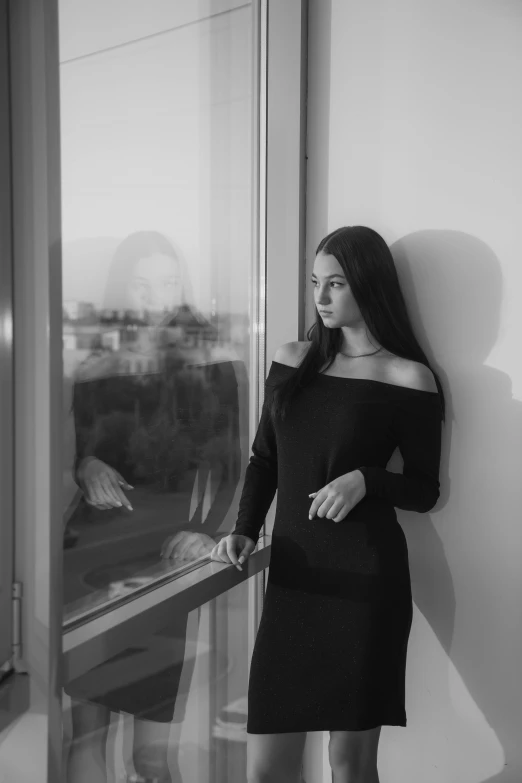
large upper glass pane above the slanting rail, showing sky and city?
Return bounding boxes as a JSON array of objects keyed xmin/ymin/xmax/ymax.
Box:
[{"xmin": 60, "ymin": 0, "xmax": 256, "ymax": 618}]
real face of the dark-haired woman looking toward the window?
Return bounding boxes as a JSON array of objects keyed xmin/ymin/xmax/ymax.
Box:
[{"xmin": 312, "ymin": 251, "xmax": 363, "ymax": 329}]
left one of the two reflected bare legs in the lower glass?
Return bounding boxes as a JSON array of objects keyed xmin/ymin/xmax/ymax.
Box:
[{"xmin": 66, "ymin": 699, "xmax": 111, "ymax": 783}]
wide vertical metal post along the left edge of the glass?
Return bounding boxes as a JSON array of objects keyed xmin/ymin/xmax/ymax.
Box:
[{"xmin": 9, "ymin": 0, "xmax": 63, "ymax": 783}]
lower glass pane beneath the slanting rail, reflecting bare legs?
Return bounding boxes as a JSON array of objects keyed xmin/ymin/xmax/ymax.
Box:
[{"xmin": 65, "ymin": 581, "xmax": 248, "ymax": 783}]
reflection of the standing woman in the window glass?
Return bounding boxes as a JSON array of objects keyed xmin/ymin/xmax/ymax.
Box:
[{"xmin": 65, "ymin": 232, "xmax": 244, "ymax": 783}]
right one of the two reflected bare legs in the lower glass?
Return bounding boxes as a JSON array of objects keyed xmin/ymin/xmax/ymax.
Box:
[{"xmin": 132, "ymin": 718, "xmax": 173, "ymax": 783}]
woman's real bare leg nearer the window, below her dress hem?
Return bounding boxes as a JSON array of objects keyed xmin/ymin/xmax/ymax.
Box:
[{"xmin": 247, "ymin": 731, "xmax": 306, "ymax": 783}]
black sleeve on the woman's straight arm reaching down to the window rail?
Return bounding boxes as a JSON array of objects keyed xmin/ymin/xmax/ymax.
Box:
[{"xmin": 232, "ymin": 384, "xmax": 277, "ymax": 541}]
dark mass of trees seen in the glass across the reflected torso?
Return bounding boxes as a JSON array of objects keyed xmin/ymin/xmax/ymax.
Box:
[{"xmin": 74, "ymin": 345, "xmax": 237, "ymax": 491}]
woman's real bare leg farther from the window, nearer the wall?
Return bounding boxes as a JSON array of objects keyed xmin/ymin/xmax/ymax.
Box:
[{"xmin": 328, "ymin": 726, "xmax": 382, "ymax": 783}]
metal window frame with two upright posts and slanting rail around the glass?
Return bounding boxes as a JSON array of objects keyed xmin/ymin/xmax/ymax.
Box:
[{"xmin": 6, "ymin": 0, "xmax": 308, "ymax": 781}]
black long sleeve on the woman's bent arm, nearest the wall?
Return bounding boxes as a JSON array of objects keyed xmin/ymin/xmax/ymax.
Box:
[{"xmin": 359, "ymin": 392, "xmax": 441, "ymax": 512}]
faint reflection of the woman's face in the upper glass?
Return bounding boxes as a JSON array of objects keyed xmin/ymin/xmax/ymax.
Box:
[{"xmin": 129, "ymin": 253, "xmax": 181, "ymax": 316}]
